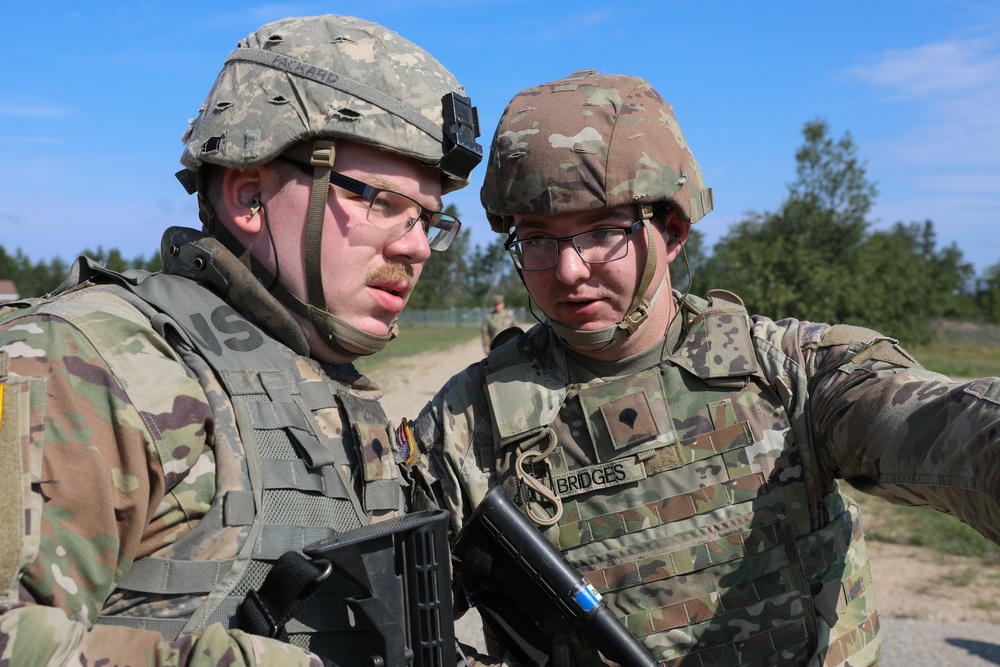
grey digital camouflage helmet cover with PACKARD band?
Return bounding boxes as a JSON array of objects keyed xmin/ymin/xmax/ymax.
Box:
[{"xmin": 181, "ymin": 15, "xmax": 482, "ymax": 192}]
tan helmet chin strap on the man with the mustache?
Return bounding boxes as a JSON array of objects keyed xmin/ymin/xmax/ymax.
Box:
[{"xmin": 292, "ymin": 140, "xmax": 399, "ymax": 357}]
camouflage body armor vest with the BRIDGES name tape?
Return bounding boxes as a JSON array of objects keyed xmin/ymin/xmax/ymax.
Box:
[{"xmin": 484, "ymin": 293, "xmax": 880, "ymax": 666}]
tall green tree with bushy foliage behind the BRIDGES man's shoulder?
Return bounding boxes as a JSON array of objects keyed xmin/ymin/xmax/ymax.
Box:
[{"xmin": 696, "ymin": 119, "xmax": 972, "ymax": 344}]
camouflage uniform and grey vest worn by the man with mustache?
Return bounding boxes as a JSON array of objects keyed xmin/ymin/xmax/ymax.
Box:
[{"xmin": 0, "ymin": 228, "xmax": 403, "ymax": 665}]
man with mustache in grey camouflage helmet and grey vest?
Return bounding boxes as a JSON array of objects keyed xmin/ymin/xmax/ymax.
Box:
[{"xmin": 0, "ymin": 15, "xmax": 482, "ymax": 667}]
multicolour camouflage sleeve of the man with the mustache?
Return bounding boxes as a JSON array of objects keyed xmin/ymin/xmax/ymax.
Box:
[{"xmin": 0, "ymin": 309, "xmax": 321, "ymax": 667}]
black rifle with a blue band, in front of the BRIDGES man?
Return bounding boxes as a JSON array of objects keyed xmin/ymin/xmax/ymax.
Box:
[{"xmin": 454, "ymin": 487, "xmax": 659, "ymax": 667}]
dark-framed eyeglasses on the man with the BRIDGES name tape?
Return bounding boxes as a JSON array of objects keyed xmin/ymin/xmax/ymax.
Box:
[{"xmin": 503, "ymin": 220, "xmax": 642, "ymax": 271}]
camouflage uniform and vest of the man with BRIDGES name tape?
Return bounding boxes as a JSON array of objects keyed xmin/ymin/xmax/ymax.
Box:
[{"xmin": 413, "ymin": 292, "xmax": 1000, "ymax": 666}]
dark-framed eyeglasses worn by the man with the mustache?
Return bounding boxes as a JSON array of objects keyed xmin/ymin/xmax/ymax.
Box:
[{"xmin": 275, "ymin": 155, "xmax": 462, "ymax": 250}]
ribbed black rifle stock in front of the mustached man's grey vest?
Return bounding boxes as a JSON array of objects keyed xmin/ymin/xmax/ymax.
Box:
[{"xmin": 303, "ymin": 510, "xmax": 457, "ymax": 667}]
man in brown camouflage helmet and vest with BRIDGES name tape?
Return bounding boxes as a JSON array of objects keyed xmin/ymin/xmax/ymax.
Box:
[{"xmin": 401, "ymin": 70, "xmax": 1000, "ymax": 665}]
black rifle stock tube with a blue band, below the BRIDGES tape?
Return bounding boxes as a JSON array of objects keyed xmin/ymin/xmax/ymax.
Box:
[{"xmin": 455, "ymin": 487, "xmax": 659, "ymax": 667}]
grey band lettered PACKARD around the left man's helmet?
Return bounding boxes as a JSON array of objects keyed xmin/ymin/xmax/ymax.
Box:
[{"xmin": 226, "ymin": 47, "xmax": 444, "ymax": 143}]
